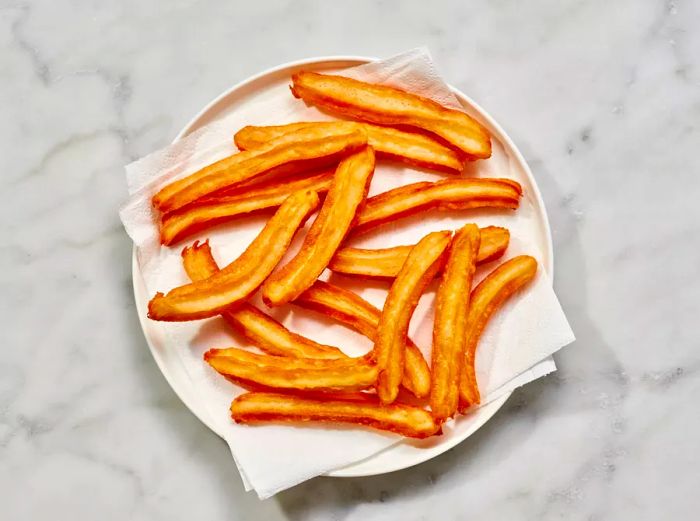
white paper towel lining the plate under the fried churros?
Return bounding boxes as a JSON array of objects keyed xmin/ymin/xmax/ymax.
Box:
[{"xmin": 120, "ymin": 49, "xmax": 574, "ymax": 498}]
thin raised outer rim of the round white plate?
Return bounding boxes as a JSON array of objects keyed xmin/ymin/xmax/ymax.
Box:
[{"xmin": 131, "ymin": 55, "xmax": 554, "ymax": 477}]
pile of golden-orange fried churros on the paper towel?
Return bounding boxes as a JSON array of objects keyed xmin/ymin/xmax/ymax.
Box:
[{"xmin": 148, "ymin": 71, "xmax": 537, "ymax": 438}]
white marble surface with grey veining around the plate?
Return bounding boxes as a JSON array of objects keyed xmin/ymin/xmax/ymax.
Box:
[{"xmin": 0, "ymin": 0, "xmax": 700, "ymax": 521}]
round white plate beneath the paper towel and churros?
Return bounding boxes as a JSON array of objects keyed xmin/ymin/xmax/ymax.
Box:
[{"xmin": 132, "ymin": 56, "xmax": 553, "ymax": 477}]
